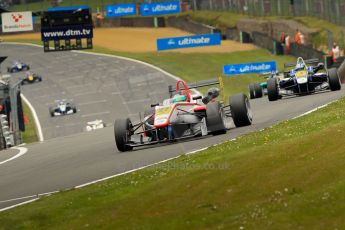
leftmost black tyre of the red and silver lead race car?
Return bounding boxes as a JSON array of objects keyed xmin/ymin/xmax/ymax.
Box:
[{"xmin": 114, "ymin": 118, "xmax": 133, "ymax": 152}]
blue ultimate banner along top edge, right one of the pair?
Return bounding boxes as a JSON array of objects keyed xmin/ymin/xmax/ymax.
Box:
[{"xmin": 140, "ymin": 1, "xmax": 181, "ymax": 16}]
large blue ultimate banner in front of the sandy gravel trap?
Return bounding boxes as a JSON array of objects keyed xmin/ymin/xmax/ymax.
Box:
[{"xmin": 157, "ymin": 34, "xmax": 221, "ymax": 51}]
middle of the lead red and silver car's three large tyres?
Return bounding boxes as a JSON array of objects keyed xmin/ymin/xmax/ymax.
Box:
[{"xmin": 206, "ymin": 102, "xmax": 226, "ymax": 135}]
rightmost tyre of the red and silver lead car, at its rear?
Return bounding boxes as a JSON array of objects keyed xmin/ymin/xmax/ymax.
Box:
[{"xmin": 229, "ymin": 93, "xmax": 253, "ymax": 127}]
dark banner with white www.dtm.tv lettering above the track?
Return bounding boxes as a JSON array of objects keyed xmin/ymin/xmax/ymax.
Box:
[{"xmin": 41, "ymin": 25, "xmax": 93, "ymax": 41}]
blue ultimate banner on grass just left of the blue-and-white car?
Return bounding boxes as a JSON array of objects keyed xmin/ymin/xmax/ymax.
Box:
[{"xmin": 223, "ymin": 61, "xmax": 277, "ymax": 75}]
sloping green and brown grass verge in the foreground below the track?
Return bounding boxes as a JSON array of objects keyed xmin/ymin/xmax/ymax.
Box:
[{"xmin": 0, "ymin": 89, "xmax": 345, "ymax": 230}]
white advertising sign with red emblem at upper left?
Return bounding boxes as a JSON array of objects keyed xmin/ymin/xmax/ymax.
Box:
[{"xmin": 1, "ymin": 11, "xmax": 34, "ymax": 33}]
